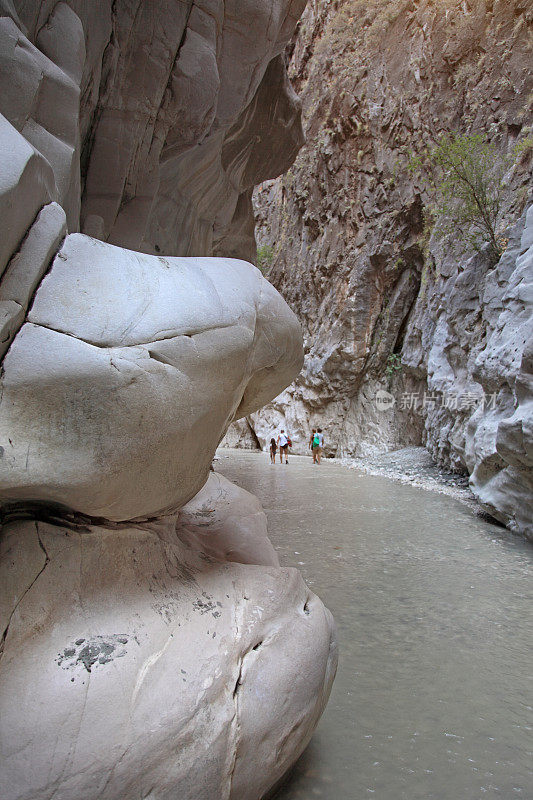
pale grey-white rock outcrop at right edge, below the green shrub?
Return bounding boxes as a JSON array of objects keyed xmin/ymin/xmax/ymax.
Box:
[{"xmin": 465, "ymin": 206, "xmax": 533, "ymax": 541}]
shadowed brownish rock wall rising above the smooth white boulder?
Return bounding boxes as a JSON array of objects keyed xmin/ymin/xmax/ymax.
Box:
[{"xmin": 13, "ymin": 0, "xmax": 304, "ymax": 255}]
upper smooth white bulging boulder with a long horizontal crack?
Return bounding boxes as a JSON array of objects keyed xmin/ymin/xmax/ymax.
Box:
[{"xmin": 0, "ymin": 234, "xmax": 302, "ymax": 520}]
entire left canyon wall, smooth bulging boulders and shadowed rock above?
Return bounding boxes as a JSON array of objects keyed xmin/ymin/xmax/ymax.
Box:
[{"xmin": 0, "ymin": 0, "xmax": 337, "ymax": 800}]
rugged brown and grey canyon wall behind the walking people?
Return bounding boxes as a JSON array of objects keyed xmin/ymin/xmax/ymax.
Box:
[{"xmin": 244, "ymin": 0, "xmax": 533, "ymax": 532}]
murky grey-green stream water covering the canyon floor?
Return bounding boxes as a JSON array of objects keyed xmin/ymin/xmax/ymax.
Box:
[{"xmin": 216, "ymin": 450, "xmax": 533, "ymax": 800}]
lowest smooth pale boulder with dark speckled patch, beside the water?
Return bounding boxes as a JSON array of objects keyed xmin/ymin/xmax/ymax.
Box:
[{"xmin": 0, "ymin": 476, "xmax": 337, "ymax": 800}]
